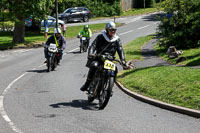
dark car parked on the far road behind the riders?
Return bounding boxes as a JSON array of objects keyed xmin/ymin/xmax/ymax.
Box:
[{"xmin": 58, "ymin": 7, "xmax": 91, "ymax": 23}]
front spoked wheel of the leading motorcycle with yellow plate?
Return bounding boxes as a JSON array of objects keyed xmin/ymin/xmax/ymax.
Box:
[{"xmin": 99, "ymin": 77, "xmax": 114, "ymax": 109}]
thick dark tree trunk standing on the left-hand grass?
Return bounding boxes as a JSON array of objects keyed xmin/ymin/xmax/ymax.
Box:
[{"xmin": 13, "ymin": 20, "xmax": 25, "ymax": 43}]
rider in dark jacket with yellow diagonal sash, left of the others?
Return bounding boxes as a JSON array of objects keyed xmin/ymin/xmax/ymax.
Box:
[{"xmin": 44, "ymin": 28, "xmax": 66, "ymax": 64}]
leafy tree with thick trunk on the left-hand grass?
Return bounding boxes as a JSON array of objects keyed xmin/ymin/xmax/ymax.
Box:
[{"xmin": 6, "ymin": 0, "xmax": 54, "ymax": 43}]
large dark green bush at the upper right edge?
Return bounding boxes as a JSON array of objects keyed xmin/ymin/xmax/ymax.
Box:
[{"xmin": 159, "ymin": 0, "xmax": 200, "ymax": 49}]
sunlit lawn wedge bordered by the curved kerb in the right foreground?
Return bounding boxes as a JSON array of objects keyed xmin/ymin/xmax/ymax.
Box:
[{"xmin": 117, "ymin": 66, "xmax": 200, "ymax": 110}]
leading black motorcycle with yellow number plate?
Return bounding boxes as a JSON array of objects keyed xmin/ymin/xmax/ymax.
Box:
[{"xmin": 87, "ymin": 55, "xmax": 121, "ymax": 109}]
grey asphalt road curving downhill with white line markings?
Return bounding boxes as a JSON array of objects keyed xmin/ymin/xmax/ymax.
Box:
[{"xmin": 0, "ymin": 12, "xmax": 200, "ymax": 133}]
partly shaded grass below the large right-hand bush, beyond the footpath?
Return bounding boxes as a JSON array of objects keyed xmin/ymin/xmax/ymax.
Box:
[{"xmin": 155, "ymin": 44, "xmax": 200, "ymax": 66}]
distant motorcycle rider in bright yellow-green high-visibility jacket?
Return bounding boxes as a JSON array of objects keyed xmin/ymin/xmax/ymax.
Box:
[{"xmin": 78, "ymin": 25, "xmax": 92, "ymax": 48}]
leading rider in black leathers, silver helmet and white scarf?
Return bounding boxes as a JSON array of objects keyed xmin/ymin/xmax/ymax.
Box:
[{"xmin": 80, "ymin": 22, "xmax": 127, "ymax": 91}]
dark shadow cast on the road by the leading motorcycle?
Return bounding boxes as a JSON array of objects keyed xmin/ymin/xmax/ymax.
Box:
[{"xmin": 49, "ymin": 99, "xmax": 99, "ymax": 110}]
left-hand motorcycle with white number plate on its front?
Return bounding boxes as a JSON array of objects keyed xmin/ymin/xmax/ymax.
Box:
[{"xmin": 47, "ymin": 43, "xmax": 59, "ymax": 72}]
